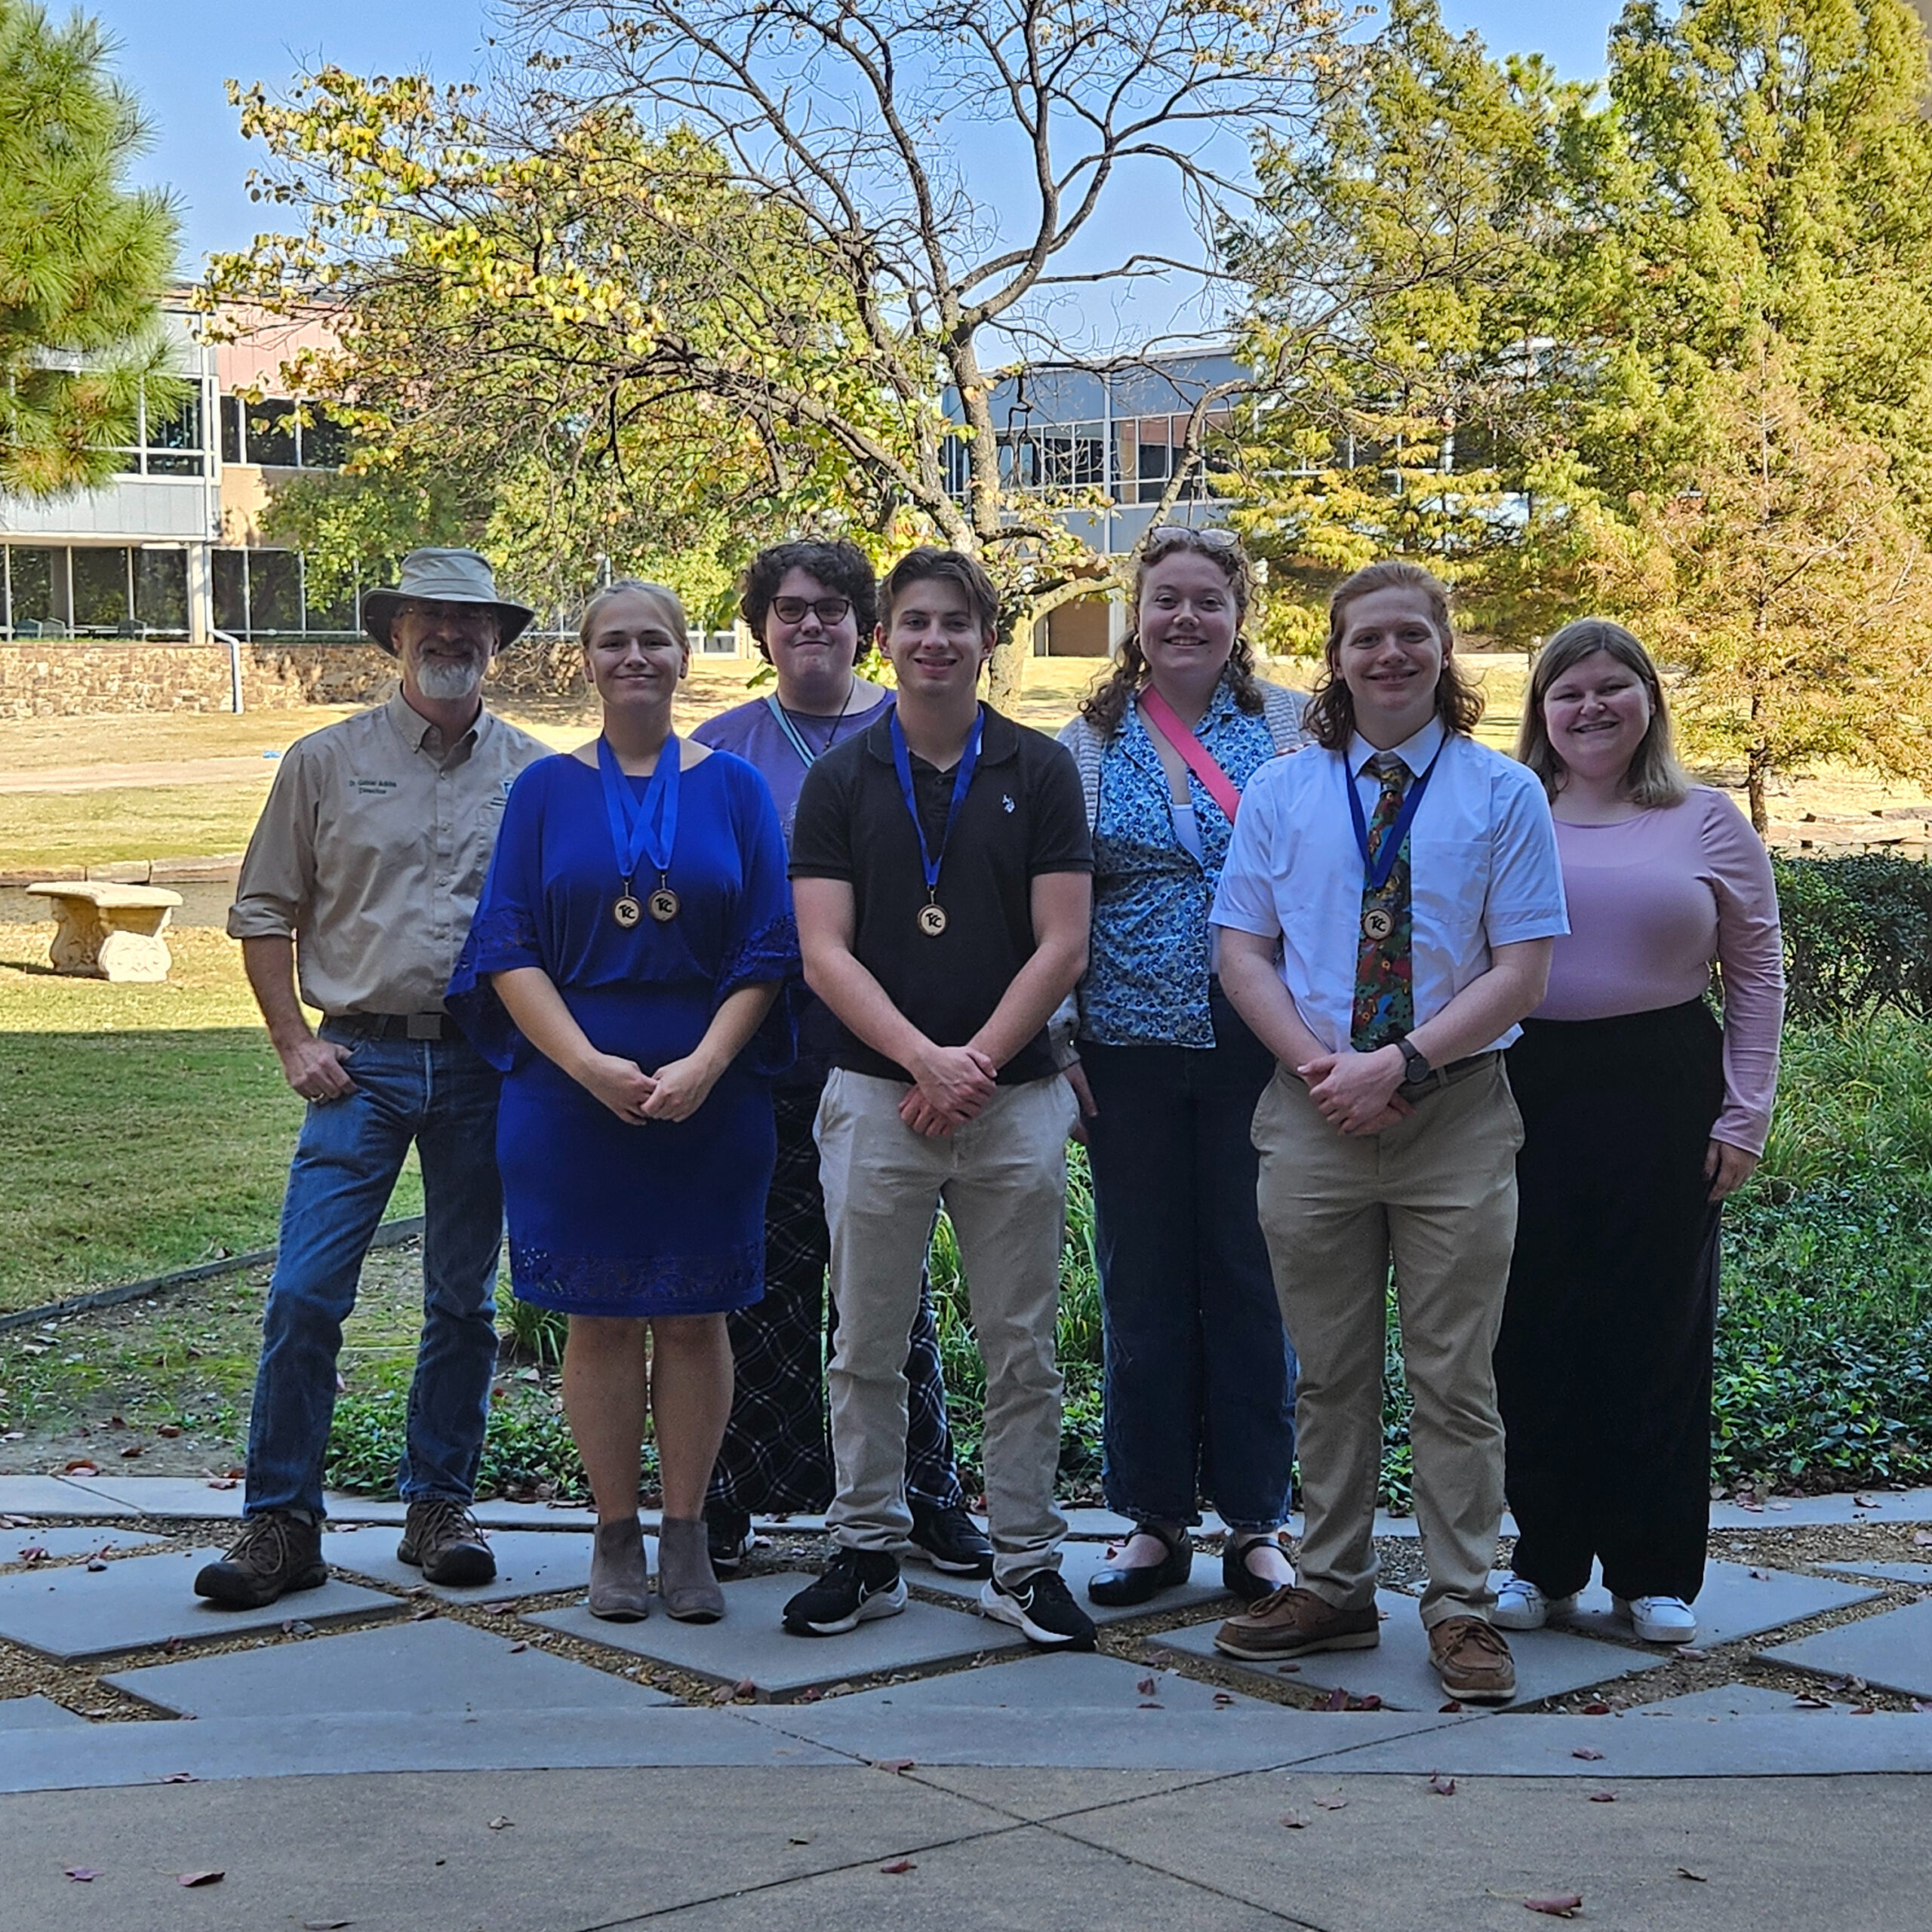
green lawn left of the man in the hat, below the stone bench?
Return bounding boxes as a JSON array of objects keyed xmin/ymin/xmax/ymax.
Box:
[{"xmin": 0, "ymin": 925, "xmax": 421, "ymax": 1310}]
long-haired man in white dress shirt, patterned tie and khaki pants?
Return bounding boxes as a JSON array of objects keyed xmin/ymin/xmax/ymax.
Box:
[{"xmin": 1211, "ymin": 562, "xmax": 1569, "ymax": 1704}]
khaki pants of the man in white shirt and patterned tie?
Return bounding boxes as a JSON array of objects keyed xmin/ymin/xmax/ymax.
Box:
[{"xmin": 1254, "ymin": 1059, "xmax": 1522, "ymax": 1625}]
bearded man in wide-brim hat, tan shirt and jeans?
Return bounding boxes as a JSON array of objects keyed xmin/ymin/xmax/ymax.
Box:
[{"xmin": 195, "ymin": 551, "xmax": 546, "ymax": 1609}]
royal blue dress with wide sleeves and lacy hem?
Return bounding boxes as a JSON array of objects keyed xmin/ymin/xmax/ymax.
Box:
[{"xmin": 448, "ymin": 752, "xmax": 798, "ymax": 1315}]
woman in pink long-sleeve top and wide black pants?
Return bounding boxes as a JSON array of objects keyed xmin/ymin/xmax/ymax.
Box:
[{"xmin": 1495, "ymin": 618, "xmax": 1785, "ymax": 1644}]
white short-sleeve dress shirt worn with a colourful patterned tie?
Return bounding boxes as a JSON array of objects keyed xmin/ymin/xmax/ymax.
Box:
[{"xmin": 1210, "ymin": 718, "xmax": 1569, "ymax": 1053}]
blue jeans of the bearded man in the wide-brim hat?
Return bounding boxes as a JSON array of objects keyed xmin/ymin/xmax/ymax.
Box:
[{"xmin": 248, "ymin": 1022, "xmax": 503, "ymax": 1517}]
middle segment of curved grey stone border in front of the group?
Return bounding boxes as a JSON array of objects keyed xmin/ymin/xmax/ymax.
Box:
[{"xmin": 746, "ymin": 1697, "xmax": 1470, "ymax": 1772}]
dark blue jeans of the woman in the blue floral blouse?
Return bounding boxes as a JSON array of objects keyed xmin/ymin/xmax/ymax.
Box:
[{"xmin": 1080, "ymin": 987, "xmax": 1294, "ymax": 1531}]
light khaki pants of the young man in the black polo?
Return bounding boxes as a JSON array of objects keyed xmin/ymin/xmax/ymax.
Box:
[{"xmin": 817, "ymin": 1069, "xmax": 1076, "ymax": 1583}]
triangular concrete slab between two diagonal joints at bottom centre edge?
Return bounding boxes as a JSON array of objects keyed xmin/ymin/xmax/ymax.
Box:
[{"xmin": 649, "ymin": 1826, "xmax": 1284, "ymax": 1932}]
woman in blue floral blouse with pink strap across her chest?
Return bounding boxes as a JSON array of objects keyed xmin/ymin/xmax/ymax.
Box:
[{"xmin": 1060, "ymin": 525, "xmax": 1306, "ymax": 1604}]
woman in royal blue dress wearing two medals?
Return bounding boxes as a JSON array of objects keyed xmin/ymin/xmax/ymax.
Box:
[{"xmin": 450, "ymin": 582, "xmax": 798, "ymax": 1621}]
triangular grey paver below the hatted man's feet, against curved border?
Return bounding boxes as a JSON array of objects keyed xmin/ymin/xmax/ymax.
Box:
[{"xmin": 106, "ymin": 1617, "xmax": 676, "ymax": 1718}]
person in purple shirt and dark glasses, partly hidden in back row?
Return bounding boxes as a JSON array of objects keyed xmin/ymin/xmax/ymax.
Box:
[{"xmin": 691, "ymin": 541, "xmax": 993, "ymax": 1577}]
